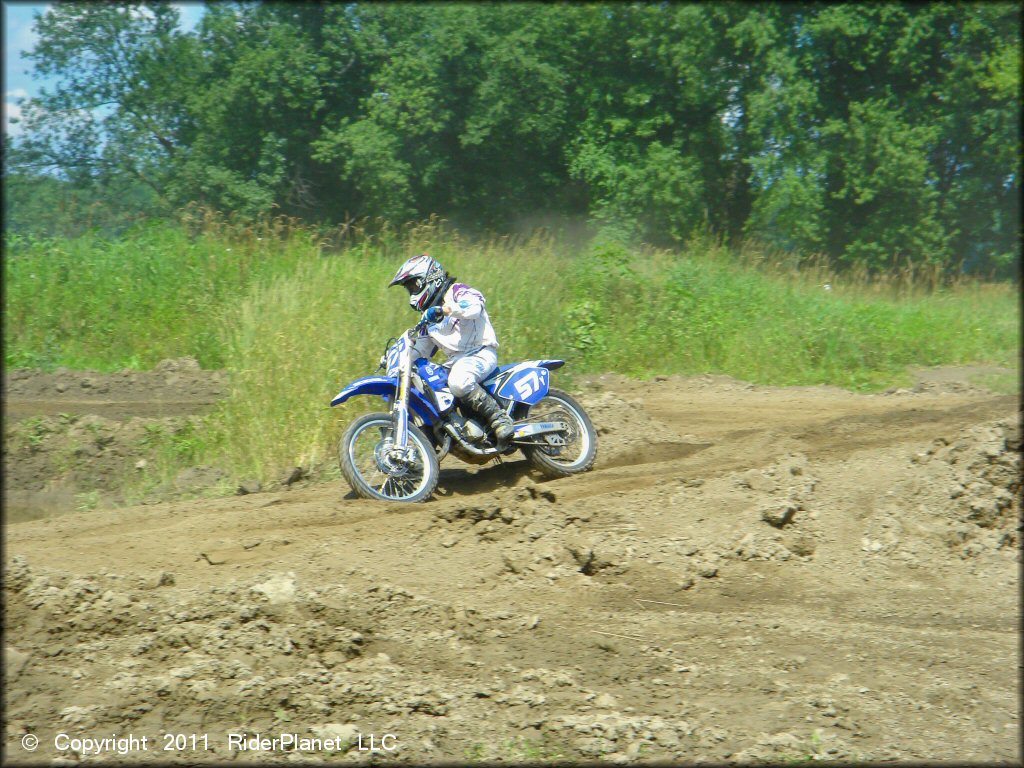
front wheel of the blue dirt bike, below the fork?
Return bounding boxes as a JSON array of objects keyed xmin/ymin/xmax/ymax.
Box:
[{"xmin": 338, "ymin": 414, "xmax": 440, "ymax": 502}]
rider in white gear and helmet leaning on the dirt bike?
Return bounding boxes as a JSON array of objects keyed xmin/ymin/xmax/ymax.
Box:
[{"xmin": 388, "ymin": 254, "xmax": 514, "ymax": 443}]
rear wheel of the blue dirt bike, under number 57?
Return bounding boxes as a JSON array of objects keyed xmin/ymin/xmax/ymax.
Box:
[{"xmin": 523, "ymin": 389, "xmax": 597, "ymax": 478}]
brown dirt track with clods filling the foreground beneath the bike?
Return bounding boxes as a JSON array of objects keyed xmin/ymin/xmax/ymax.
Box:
[{"xmin": 4, "ymin": 368, "xmax": 1021, "ymax": 764}]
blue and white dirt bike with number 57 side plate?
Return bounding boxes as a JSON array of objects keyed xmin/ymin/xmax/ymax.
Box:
[{"xmin": 331, "ymin": 326, "xmax": 597, "ymax": 502}]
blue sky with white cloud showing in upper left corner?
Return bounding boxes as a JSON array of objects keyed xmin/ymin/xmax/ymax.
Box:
[{"xmin": 3, "ymin": 0, "xmax": 204, "ymax": 135}]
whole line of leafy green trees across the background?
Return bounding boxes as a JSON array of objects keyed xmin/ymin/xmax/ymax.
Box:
[{"xmin": 5, "ymin": 2, "xmax": 1021, "ymax": 274}]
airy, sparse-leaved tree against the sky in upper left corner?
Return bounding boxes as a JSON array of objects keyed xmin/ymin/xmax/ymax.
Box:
[{"xmin": 11, "ymin": 2, "xmax": 196, "ymax": 204}]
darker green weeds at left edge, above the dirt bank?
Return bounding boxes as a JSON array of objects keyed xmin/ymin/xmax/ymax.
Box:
[{"xmin": 3, "ymin": 218, "xmax": 316, "ymax": 371}]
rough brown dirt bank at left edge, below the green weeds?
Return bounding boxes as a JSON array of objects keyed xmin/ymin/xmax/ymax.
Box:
[{"xmin": 3, "ymin": 357, "xmax": 226, "ymax": 521}]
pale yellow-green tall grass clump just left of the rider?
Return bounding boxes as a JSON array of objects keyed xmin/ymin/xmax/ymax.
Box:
[{"xmin": 208, "ymin": 252, "xmax": 391, "ymax": 476}]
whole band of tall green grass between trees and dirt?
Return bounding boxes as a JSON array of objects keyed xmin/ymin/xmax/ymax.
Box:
[{"xmin": 4, "ymin": 212, "xmax": 1019, "ymax": 493}]
